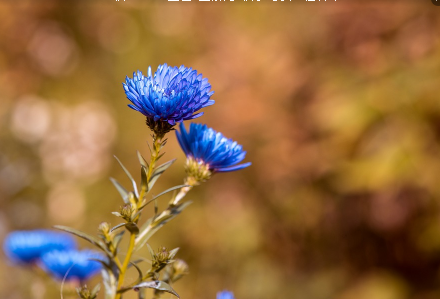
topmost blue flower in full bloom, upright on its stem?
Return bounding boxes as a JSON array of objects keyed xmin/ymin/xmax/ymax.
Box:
[{"xmin": 123, "ymin": 64, "xmax": 214, "ymax": 126}]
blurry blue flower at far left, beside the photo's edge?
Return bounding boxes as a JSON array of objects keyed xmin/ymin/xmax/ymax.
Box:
[{"xmin": 3, "ymin": 230, "xmax": 76, "ymax": 264}]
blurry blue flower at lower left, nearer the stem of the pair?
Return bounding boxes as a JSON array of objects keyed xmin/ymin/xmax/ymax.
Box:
[{"xmin": 40, "ymin": 250, "xmax": 105, "ymax": 280}]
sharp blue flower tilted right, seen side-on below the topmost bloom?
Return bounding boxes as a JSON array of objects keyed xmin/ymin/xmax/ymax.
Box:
[{"xmin": 176, "ymin": 123, "xmax": 251, "ymax": 172}]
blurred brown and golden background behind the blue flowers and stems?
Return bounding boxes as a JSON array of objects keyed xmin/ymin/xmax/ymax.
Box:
[{"xmin": 0, "ymin": 0, "xmax": 440, "ymax": 299}]
